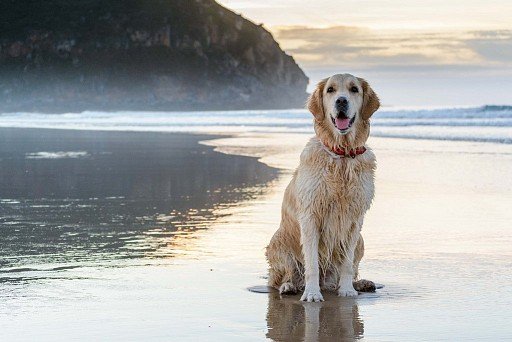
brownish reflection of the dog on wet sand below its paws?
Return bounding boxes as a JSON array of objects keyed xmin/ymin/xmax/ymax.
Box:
[{"xmin": 267, "ymin": 291, "xmax": 364, "ymax": 342}]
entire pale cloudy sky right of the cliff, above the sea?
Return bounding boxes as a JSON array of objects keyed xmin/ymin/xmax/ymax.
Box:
[{"xmin": 218, "ymin": 0, "xmax": 512, "ymax": 107}]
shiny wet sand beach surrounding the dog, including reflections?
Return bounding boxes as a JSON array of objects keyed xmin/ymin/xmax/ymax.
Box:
[{"xmin": 0, "ymin": 130, "xmax": 512, "ymax": 341}]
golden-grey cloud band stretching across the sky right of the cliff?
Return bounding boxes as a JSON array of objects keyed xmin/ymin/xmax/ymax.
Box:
[{"xmin": 274, "ymin": 26, "xmax": 512, "ymax": 68}]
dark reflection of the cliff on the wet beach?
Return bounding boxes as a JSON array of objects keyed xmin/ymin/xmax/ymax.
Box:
[{"xmin": 0, "ymin": 128, "xmax": 279, "ymax": 270}]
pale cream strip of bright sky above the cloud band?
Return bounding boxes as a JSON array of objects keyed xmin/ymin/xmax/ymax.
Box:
[{"xmin": 218, "ymin": 0, "xmax": 512, "ymax": 30}]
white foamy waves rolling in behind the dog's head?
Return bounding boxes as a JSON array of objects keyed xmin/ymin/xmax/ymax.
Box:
[{"xmin": 0, "ymin": 105, "xmax": 512, "ymax": 144}]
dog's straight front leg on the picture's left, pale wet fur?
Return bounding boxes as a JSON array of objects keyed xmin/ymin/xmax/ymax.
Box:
[{"xmin": 299, "ymin": 215, "xmax": 324, "ymax": 302}]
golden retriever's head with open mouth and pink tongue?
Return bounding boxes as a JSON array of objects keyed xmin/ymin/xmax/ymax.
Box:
[{"xmin": 307, "ymin": 74, "xmax": 380, "ymax": 146}]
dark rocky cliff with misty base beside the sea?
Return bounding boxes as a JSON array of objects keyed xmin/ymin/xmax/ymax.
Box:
[{"xmin": 0, "ymin": 0, "xmax": 308, "ymax": 112}]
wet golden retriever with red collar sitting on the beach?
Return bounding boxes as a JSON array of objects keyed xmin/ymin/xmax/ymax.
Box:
[{"xmin": 266, "ymin": 74, "xmax": 380, "ymax": 302}]
